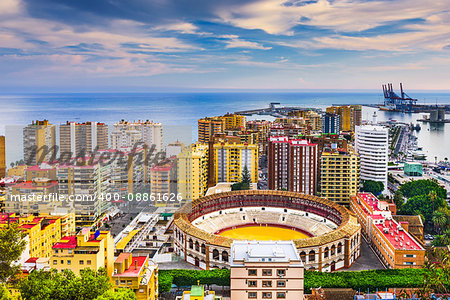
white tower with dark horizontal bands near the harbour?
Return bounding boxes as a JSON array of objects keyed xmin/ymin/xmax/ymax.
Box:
[{"xmin": 355, "ymin": 125, "xmax": 389, "ymax": 191}]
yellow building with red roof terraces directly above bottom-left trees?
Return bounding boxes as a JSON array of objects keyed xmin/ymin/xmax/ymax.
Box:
[{"xmin": 50, "ymin": 227, "xmax": 114, "ymax": 277}]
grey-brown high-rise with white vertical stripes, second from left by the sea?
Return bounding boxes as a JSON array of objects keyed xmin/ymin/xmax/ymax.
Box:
[{"xmin": 59, "ymin": 121, "xmax": 108, "ymax": 157}]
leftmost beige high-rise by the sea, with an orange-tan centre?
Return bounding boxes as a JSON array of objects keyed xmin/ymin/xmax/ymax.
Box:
[{"xmin": 23, "ymin": 120, "xmax": 57, "ymax": 165}]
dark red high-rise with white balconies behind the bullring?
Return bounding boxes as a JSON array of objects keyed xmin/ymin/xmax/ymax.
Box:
[{"xmin": 268, "ymin": 136, "xmax": 318, "ymax": 195}]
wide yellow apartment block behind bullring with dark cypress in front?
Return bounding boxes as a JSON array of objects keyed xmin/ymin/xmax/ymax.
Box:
[{"xmin": 214, "ymin": 143, "xmax": 259, "ymax": 183}]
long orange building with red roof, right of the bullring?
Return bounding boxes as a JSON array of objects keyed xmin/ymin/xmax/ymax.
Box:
[{"xmin": 350, "ymin": 193, "xmax": 425, "ymax": 269}]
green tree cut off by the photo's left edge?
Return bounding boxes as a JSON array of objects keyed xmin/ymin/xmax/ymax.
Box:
[{"xmin": 0, "ymin": 224, "xmax": 26, "ymax": 283}]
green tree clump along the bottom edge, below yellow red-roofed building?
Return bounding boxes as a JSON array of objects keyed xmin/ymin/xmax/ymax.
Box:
[{"xmin": 19, "ymin": 269, "xmax": 111, "ymax": 300}]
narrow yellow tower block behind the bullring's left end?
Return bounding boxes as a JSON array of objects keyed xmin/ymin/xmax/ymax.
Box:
[{"xmin": 177, "ymin": 144, "xmax": 208, "ymax": 201}]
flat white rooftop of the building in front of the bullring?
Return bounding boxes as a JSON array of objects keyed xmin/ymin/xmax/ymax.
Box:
[{"xmin": 231, "ymin": 241, "xmax": 303, "ymax": 265}]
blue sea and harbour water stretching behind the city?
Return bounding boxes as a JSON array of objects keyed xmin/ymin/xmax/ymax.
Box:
[{"xmin": 0, "ymin": 91, "xmax": 450, "ymax": 165}]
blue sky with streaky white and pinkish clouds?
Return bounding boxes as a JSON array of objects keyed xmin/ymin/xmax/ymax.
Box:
[{"xmin": 0, "ymin": 0, "xmax": 450, "ymax": 93}]
